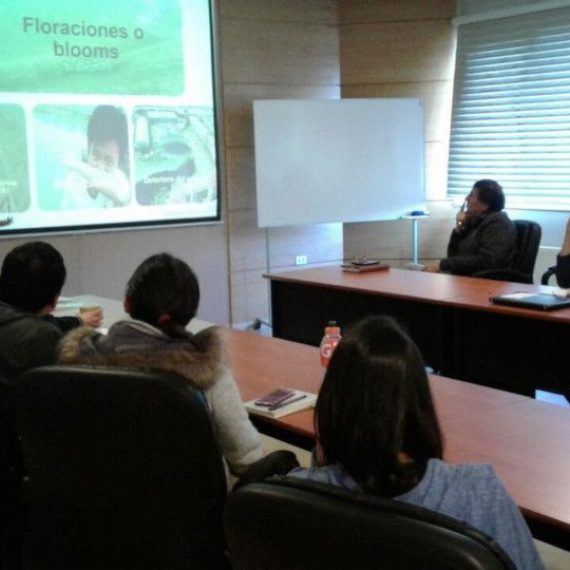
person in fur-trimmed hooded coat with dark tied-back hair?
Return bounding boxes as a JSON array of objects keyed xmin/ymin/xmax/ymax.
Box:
[{"xmin": 59, "ymin": 253, "xmax": 262, "ymax": 475}]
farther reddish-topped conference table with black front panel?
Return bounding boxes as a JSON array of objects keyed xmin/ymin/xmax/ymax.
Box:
[{"xmin": 266, "ymin": 266, "xmax": 570, "ymax": 395}]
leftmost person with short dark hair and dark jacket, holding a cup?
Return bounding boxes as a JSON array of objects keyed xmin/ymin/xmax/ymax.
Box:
[{"xmin": 0, "ymin": 241, "xmax": 102, "ymax": 380}]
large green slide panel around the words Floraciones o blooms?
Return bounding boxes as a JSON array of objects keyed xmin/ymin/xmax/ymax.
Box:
[{"xmin": 0, "ymin": 0, "xmax": 184, "ymax": 96}]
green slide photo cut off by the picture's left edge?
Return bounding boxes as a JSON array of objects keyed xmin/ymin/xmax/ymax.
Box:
[{"xmin": 0, "ymin": 105, "xmax": 30, "ymax": 215}]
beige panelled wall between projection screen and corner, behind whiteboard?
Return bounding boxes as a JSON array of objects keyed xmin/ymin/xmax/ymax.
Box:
[{"xmin": 219, "ymin": 0, "xmax": 342, "ymax": 324}]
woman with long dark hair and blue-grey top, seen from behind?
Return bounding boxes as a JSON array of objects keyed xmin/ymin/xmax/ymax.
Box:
[{"xmin": 290, "ymin": 317, "xmax": 543, "ymax": 569}]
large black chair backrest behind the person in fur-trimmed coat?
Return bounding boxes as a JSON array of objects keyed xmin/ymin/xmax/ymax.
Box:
[{"xmin": 15, "ymin": 366, "xmax": 227, "ymax": 570}]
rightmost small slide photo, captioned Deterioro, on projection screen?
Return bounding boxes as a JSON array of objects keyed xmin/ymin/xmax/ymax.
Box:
[{"xmin": 133, "ymin": 106, "xmax": 217, "ymax": 206}]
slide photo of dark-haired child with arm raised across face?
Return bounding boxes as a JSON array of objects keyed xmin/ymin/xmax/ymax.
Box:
[{"xmin": 34, "ymin": 105, "xmax": 131, "ymax": 210}]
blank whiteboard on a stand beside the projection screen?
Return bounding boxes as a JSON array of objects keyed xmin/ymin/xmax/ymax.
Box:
[{"xmin": 253, "ymin": 98, "xmax": 425, "ymax": 227}]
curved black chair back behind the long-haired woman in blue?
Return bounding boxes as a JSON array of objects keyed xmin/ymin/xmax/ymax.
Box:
[{"xmin": 224, "ymin": 477, "xmax": 515, "ymax": 570}]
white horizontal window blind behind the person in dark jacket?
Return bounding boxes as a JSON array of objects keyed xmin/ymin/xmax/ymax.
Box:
[{"xmin": 448, "ymin": 8, "xmax": 570, "ymax": 209}]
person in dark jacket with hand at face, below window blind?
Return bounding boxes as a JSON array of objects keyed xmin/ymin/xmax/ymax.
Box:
[{"xmin": 425, "ymin": 180, "xmax": 517, "ymax": 275}]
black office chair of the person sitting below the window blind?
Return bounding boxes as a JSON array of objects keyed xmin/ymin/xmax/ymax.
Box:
[{"xmin": 473, "ymin": 220, "xmax": 542, "ymax": 283}]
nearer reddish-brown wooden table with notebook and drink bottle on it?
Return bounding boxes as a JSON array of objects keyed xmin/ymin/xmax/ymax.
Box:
[{"xmin": 228, "ymin": 330, "xmax": 570, "ymax": 550}]
